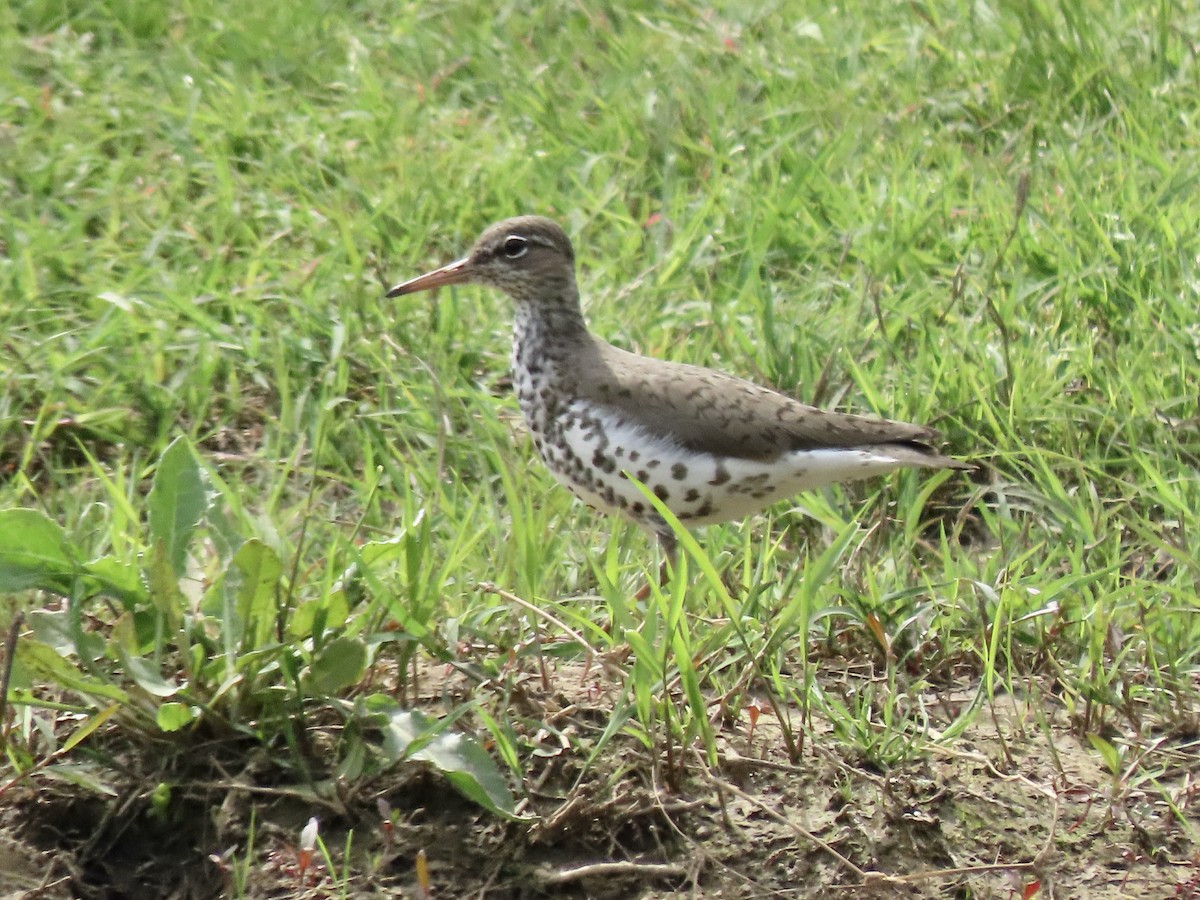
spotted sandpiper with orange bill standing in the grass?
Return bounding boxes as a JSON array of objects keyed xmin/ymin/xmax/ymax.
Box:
[{"xmin": 388, "ymin": 216, "xmax": 972, "ymax": 557}]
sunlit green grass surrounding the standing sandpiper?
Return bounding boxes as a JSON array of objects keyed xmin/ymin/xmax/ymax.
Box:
[{"xmin": 0, "ymin": 0, "xmax": 1200, "ymax": 897}]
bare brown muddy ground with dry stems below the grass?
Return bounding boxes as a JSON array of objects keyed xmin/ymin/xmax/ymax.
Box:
[{"xmin": 0, "ymin": 668, "xmax": 1200, "ymax": 900}]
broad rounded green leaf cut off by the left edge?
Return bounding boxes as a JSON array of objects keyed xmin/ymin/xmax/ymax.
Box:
[{"xmin": 0, "ymin": 509, "xmax": 79, "ymax": 595}]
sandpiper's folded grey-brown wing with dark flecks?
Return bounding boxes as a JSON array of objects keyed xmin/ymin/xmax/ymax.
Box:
[{"xmin": 576, "ymin": 341, "xmax": 970, "ymax": 468}]
